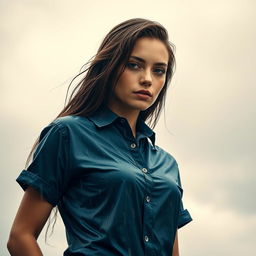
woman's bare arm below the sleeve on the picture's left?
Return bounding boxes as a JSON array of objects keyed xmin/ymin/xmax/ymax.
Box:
[{"xmin": 7, "ymin": 187, "xmax": 53, "ymax": 256}]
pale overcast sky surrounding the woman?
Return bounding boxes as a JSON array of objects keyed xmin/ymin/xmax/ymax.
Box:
[{"xmin": 0, "ymin": 0, "xmax": 256, "ymax": 256}]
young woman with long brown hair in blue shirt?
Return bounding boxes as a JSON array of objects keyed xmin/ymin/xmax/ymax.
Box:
[{"xmin": 8, "ymin": 19, "xmax": 191, "ymax": 256}]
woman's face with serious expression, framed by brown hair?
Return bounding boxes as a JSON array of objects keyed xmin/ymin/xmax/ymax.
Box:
[{"xmin": 108, "ymin": 38, "xmax": 169, "ymax": 117}]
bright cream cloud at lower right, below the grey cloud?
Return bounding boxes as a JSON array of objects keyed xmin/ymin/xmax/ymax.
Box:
[{"xmin": 179, "ymin": 201, "xmax": 256, "ymax": 256}]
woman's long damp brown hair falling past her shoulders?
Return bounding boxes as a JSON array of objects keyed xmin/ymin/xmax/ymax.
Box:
[{"xmin": 26, "ymin": 18, "xmax": 175, "ymax": 238}]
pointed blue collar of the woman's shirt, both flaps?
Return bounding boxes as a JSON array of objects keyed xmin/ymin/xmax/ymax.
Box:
[{"xmin": 88, "ymin": 106, "xmax": 155, "ymax": 148}]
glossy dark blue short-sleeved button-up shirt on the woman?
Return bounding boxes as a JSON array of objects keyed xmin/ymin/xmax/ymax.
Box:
[{"xmin": 17, "ymin": 108, "xmax": 192, "ymax": 256}]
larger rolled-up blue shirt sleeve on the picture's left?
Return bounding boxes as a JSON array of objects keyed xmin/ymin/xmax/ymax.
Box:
[{"xmin": 16, "ymin": 122, "xmax": 71, "ymax": 206}]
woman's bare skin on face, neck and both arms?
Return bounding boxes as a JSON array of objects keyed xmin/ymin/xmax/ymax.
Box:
[{"xmin": 7, "ymin": 38, "xmax": 179, "ymax": 256}]
